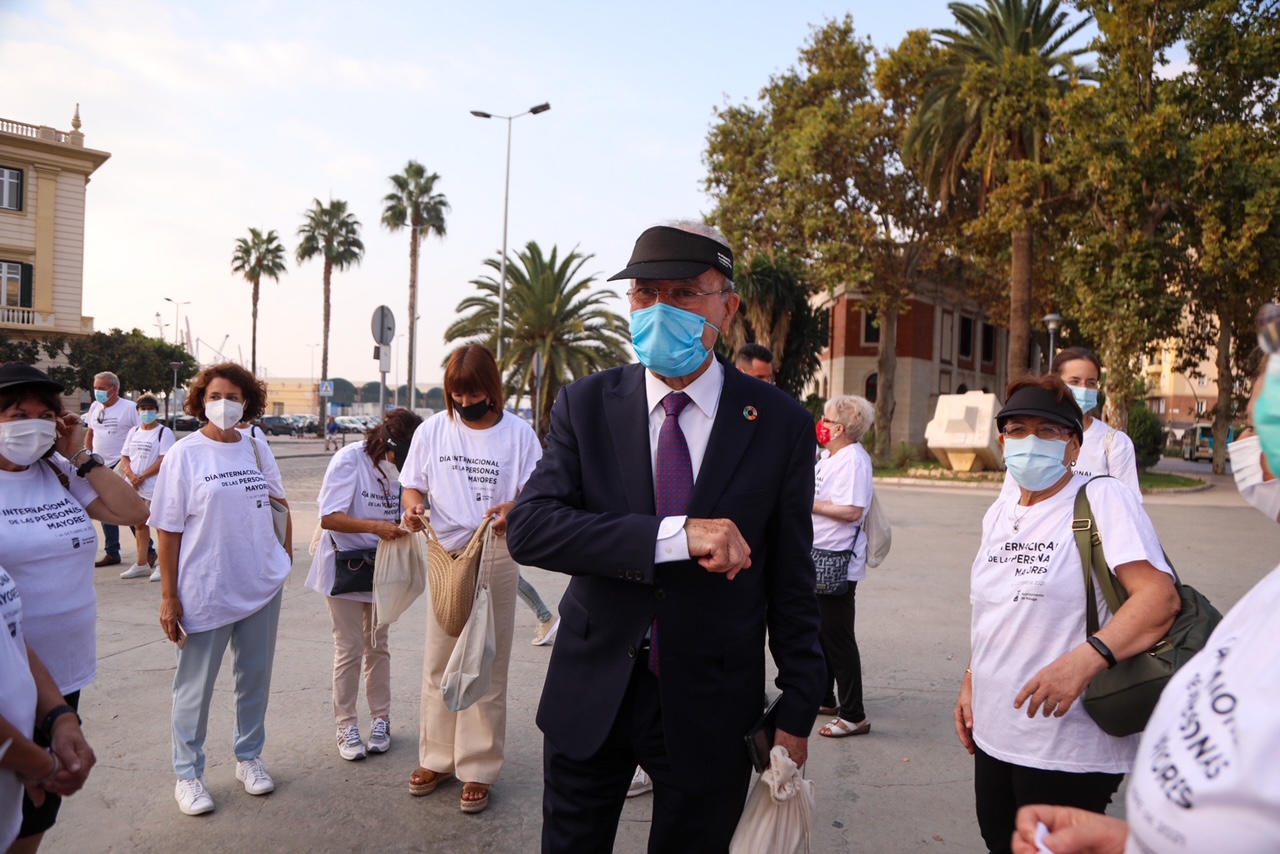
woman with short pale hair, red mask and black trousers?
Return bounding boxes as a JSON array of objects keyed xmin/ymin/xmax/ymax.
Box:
[{"xmin": 813, "ymin": 394, "xmax": 876, "ymax": 739}]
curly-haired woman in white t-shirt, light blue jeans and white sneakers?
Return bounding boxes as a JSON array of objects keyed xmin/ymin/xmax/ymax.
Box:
[{"xmin": 150, "ymin": 362, "xmax": 293, "ymax": 816}]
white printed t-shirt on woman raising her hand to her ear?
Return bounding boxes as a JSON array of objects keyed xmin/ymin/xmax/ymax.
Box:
[{"xmin": 0, "ymin": 453, "xmax": 97, "ymax": 694}]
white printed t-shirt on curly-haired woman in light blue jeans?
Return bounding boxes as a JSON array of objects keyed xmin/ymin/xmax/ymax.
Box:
[{"xmin": 147, "ymin": 431, "xmax": 289, "ymax": 632}]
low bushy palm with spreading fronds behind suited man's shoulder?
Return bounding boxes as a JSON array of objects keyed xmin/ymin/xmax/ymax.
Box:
[{"xmin": 444, "ymin": 241, "xmax": 631, "ymax": 437}]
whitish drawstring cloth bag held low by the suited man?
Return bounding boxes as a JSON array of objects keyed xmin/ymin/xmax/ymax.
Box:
[{"xmin": 728, "ymin": 745, "xmax": 814, "ymax": 854}]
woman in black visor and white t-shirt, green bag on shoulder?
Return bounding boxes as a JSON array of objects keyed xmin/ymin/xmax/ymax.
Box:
[{"xmin": 955, "ymin": 376, "xmax": 1180, "ymax": 851}]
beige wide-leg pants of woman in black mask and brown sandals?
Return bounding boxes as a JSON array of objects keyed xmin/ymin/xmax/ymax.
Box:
[{"xmin": 419, "ymin": 536, "xmax": 520, "ymax": 784}]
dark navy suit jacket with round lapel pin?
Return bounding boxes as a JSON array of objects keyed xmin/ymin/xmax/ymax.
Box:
[{"xmin": 507, "ymin": 362, "xmax": 827, "ymax": 775}]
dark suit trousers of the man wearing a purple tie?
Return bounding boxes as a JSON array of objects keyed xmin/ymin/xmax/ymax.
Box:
[{"xmin": 543, "ymin": 654, "xmax": 751, "ymax": 854}]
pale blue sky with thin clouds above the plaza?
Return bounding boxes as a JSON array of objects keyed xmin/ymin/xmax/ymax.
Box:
[{"xmin": 0, "ymin": 0, "xmax": 1044, "ymax": 382}]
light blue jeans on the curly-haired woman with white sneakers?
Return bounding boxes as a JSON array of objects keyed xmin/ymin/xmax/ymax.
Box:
[{"xmin": 173, "ymin": 588, "xmax": 284, "ymax": 780}]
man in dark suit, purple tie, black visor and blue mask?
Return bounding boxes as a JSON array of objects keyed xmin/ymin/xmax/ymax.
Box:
[{"xmin": 507, "ymin": 217, "xmax": 826, "ymax": 854}]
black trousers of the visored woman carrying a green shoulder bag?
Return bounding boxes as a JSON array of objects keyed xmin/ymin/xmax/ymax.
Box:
[{"xmin": 973, "ymin": 748, "xmax": 1124, "ymax": 854}]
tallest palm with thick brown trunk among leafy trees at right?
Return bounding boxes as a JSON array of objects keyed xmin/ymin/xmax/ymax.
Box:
[{"xmin": 905, "ymin": 0, "xmax": 1091, "ymax": 379}]
